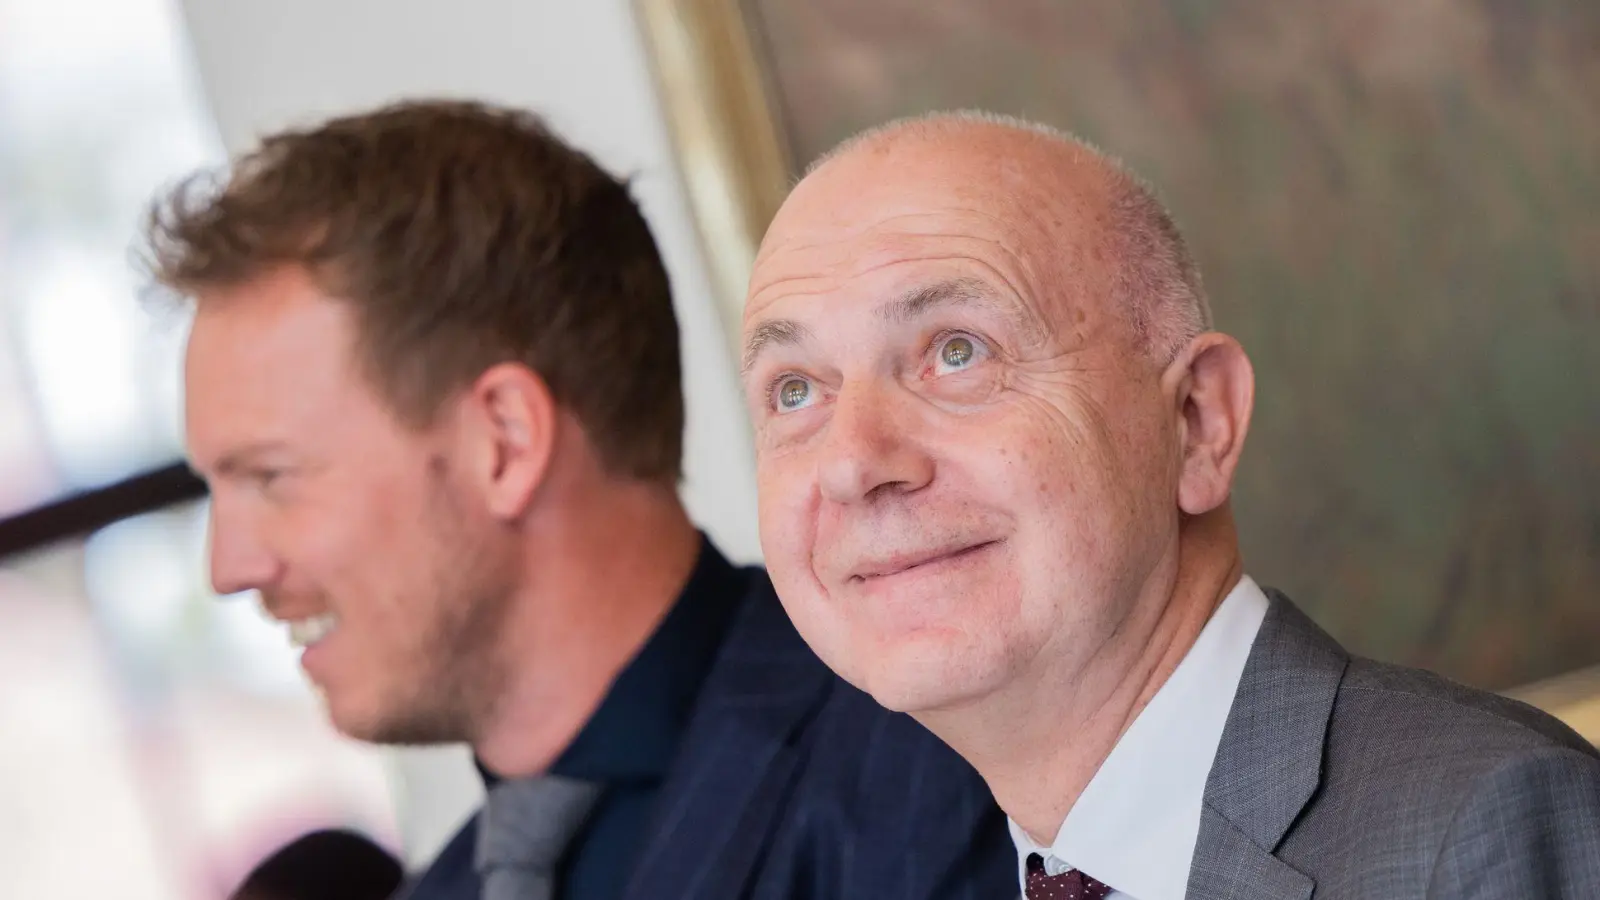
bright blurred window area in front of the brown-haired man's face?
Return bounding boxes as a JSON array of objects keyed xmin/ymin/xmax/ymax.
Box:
[{"xmin": 0, "ymin": 0, "xmax": 398, "ymax": 900}]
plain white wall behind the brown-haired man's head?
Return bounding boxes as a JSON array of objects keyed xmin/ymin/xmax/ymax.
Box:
[{"xmin": 182, "ymin": 0, "xmax": 760, "ymax": 860}]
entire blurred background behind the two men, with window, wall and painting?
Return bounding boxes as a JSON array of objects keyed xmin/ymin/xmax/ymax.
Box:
[{"xmin": 0, "ymin": 0, "xmax": 1600, "ymax": 900}]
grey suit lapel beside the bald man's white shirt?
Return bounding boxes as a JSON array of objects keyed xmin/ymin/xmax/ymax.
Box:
[{"xmin": 1187, "ymin": 591, "xmax": 1349, "ymax": 900}]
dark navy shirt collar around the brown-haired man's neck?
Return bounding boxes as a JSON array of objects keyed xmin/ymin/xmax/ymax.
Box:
[{"xmin": 478, "ymin": 536, "xmax": 746, "ymax": 788}]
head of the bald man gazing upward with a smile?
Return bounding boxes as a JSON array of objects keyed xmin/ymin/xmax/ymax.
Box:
[{"xmin": 742, "ymin": 115, "xmax": 1253, "ymax": 714}]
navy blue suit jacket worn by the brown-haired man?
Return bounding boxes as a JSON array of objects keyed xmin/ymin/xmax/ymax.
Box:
[{"xmin": 402, "ymin": 569, "xmax": 1018, "ymax": 900}]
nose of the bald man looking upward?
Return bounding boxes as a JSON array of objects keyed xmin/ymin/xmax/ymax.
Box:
[{"xmin": 818, "ymin": 384, "xmax": 933, "ymax": 503}]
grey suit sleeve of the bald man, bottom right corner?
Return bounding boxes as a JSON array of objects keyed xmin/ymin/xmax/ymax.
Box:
[{"xmin": 1427, "ymin": 748, "xmax": 1600, "ymax": 900}]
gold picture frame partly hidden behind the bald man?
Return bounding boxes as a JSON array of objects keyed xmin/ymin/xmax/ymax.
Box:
[{"xmin": 635, "ymin": 0, "xmax": 1600, "ymax": 745}]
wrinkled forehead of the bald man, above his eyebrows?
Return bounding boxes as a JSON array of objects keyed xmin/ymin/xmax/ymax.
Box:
[{"xmin": 744, "ymin": 128, "xmax": 1109, "ymax": 347}]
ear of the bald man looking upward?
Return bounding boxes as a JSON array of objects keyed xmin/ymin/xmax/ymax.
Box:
[{"xmin": 1162, "ymin": 331, "xmax": 1256, "ymax": 516}]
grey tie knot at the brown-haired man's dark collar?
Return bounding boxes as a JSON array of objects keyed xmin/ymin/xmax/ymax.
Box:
[{"xmin": 474, "ymin": 775, "xmax": 600, "ymax": 871}]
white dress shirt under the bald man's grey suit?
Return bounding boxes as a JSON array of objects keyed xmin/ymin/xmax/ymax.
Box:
[{"xmin": 1010, "ymin": 575, "xmax": 1267, "ymax": 900}]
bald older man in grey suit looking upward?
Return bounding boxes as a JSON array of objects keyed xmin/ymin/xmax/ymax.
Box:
[{"xmin": 744, "ymin": 115, "xmax": 1600, "ymax": 900}]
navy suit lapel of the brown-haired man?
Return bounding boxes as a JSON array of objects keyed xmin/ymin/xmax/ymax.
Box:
[{"xmin": 624, "ymin": 575, "xmax": 834, "ymax": 900}]
